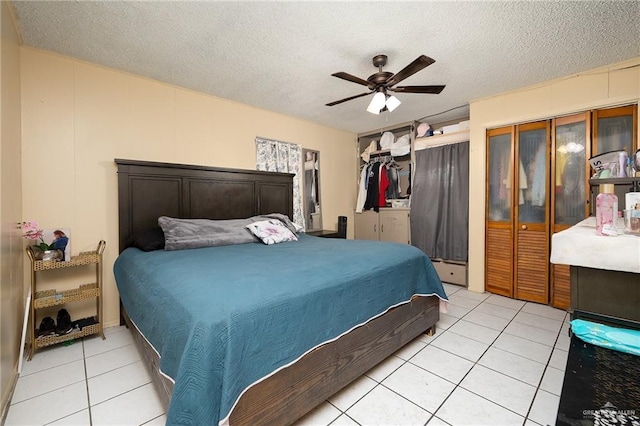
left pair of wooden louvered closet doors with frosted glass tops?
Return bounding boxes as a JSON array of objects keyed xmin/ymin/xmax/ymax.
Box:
[{"xmin": 486, "ymin": 121, "xmax": 550, "ymax": 303}]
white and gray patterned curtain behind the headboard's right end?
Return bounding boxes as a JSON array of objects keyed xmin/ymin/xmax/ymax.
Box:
[{"xmin": 256, "ymin": 138, "xmax": 304, "ymax": 227}]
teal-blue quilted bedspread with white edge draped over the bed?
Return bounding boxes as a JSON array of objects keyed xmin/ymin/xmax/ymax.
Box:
[{"xmin": 114, "ymin": 234, "xmax": 446, "ymax": 425}]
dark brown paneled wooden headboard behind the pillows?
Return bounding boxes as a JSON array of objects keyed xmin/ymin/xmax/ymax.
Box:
[{"xmin": 115, "ymin": 158, "xmax": 294, "ymax": 252}]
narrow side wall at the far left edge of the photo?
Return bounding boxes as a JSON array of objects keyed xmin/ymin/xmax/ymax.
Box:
[{"xmin": 0, "ymin": 1, "xmax": 25, "ymax": 422}]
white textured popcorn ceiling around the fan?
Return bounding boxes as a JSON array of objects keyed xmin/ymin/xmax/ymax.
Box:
[{"xmin": 13, "ymin": 1, "xmax": 640, "ymax": 132}]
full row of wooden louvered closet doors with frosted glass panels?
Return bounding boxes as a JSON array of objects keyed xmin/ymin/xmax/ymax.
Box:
[{"xmin": 485, "ymin": 105, "xmax": 637, "ymax": 309}]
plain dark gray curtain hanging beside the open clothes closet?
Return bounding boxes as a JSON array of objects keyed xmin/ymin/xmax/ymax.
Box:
[{"xmin": 411, "ymin": 142, "xmax": 469, "ymax": 262}]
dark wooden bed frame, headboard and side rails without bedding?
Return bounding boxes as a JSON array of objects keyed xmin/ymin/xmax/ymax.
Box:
[{"xmin": 115, "ymin": 159, "xmax": 439, "ymax": 425}]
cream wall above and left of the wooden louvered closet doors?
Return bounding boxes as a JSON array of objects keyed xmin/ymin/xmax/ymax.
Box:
[{"xmin": 468, "ymin": 58, "xmax": 640, "ymax": 292}]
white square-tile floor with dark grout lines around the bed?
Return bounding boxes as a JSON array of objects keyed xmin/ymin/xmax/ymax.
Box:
[{"xmin": 6, "ymin": 284, "xmax": 569, "ymax": 426}]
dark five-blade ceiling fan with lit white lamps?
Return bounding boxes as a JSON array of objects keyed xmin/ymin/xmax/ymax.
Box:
[{"xmin": 327, "ymin": 55, "xmax": 445, "ymax": 114}]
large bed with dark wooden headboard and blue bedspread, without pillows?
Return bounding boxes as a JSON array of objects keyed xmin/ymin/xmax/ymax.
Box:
[{"xmin": 114, "ymin": 159, "xmax": 446, "ymax": 425}]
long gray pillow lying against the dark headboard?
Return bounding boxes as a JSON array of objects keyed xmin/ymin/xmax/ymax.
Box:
[{"xmin": 158, "ymin": 216, "xmax": 258, "ymax": 250}]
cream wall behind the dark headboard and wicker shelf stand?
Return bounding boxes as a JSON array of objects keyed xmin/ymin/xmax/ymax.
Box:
[{"xmin": 21, "ymin": 47, "xmax": 357, "ymax": 326}]
